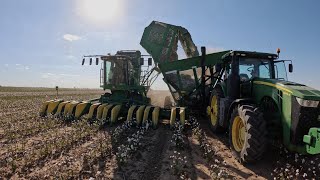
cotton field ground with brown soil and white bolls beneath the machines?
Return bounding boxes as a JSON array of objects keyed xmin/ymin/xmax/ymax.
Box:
[{"xmin": 0, "ymin": 87, "xmax": 320, "ymax": 179}]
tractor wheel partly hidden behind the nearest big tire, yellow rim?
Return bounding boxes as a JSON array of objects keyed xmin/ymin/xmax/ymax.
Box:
[{"xmin": 208, "ymin": 88, "xmax": 226, "ymax": 133}]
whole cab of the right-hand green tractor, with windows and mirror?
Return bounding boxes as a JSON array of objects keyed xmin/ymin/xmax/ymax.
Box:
[{"xmin": 220, "ymin": 51, "xmax": 292, "ymax": 99}]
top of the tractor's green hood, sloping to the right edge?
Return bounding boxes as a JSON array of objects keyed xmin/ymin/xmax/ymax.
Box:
[{"xmin": 254, "ymin": 78, "xmax": 320, "ymax": 100}]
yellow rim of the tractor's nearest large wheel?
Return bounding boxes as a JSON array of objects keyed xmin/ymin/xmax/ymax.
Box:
[{"xmin": 232, "ymin": 116, "xmax": 246, "ymax": 152}]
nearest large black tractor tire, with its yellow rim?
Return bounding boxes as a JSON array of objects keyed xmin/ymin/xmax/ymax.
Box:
[{"xmin": 229, "ymin": 105, "xmax": 267, "ymax": 163}]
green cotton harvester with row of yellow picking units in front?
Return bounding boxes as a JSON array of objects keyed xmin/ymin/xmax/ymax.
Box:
[{"xmin": 40, "ymin": 50, "xmax": 168, "ymax": 127}]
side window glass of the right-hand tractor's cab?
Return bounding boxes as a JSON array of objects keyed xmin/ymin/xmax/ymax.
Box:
[{"xmin": 239, "ymin": 58, "xmax": 271, "ymax": 82}]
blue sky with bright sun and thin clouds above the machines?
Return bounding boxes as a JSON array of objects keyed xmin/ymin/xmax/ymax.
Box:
[{"xmin": 0, "ymin": 0, "xmax": 320, "ymax": 89}]
